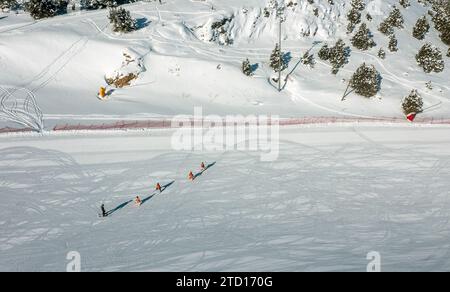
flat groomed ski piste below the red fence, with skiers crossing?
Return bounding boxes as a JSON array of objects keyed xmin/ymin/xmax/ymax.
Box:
[{"xmin": 0, "ymin": 125, "xmax": 450, "ymax": 271}]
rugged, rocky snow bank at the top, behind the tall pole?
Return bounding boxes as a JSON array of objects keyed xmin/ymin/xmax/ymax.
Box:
[{"xmin": 193, "ymin": 0, "xmax": 350, "ymax": 45}]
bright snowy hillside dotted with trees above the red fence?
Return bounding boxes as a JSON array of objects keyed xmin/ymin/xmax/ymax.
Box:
[{"xmin": 0, "ymin": 0, "xmax": 450, "ymax": 129}]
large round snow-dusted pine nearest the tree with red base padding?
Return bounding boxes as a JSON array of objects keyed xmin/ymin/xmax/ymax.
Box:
[{"xmin": 350, "ymin": 63, "xmax": 381, "ymax": 98}]
